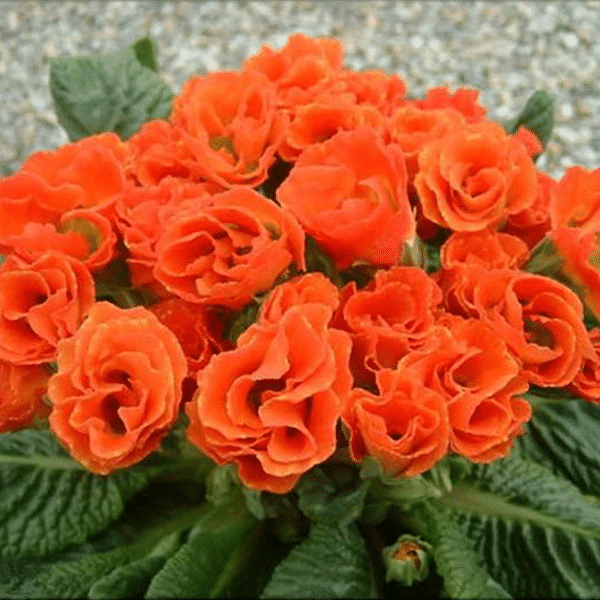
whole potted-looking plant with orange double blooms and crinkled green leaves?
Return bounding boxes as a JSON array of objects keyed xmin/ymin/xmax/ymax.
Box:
[{"xmin": 0, "ymin": 34, "xmax": 600, "ymax": 598}]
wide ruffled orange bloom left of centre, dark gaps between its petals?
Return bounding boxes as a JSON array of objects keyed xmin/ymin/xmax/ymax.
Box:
[{"xmin": 154, "ymin": 186, "xmax": 305, "ymax": 310}]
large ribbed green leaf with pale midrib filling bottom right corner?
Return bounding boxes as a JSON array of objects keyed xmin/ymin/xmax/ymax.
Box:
[{"xmin": 431, "ymin": 448, "xmax": 600, "ymax": 598}]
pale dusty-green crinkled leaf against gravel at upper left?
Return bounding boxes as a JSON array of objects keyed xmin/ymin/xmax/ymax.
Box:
[{"xmin": 50, "ymin": 44, "xmax": 173, "ymax": 141}]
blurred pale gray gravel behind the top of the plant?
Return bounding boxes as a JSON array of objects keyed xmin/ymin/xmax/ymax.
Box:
[{"xmin": 0, "ymin": 0, "xmax": 600, "ymax": 177}]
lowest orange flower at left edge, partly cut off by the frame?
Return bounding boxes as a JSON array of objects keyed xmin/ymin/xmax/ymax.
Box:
[{"xmin": 0, "ymin": 361, "xmax": 50, "ymax": 433}]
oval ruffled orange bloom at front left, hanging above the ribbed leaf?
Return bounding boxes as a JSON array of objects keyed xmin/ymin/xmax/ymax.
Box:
[{"xmin": 48, "ymin": 302, "xmax": 187, "ymax": 475}]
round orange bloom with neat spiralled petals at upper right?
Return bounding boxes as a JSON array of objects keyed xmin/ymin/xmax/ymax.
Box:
[{"xmin": 414, "ymin": 122, "xmax": 537, "ymax": 231}]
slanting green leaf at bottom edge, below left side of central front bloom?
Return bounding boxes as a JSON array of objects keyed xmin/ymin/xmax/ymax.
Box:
[{"xmin": 145, "ymin": 503, "xmax": 256, "ymax": 598}]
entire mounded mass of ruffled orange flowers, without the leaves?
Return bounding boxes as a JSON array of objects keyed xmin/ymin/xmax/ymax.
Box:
[{"xmin": 0, "ymin": 34, "xmax": 600, "ymax": 493}]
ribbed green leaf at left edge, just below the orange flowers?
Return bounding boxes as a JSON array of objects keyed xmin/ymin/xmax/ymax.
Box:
[{"xmin": 0, "ymin": 430, "xmax": 148, "ymax": 557}]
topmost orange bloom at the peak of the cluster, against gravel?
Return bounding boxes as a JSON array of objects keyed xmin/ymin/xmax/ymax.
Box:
[{"xmin": 242, "ymin": 33, "xmax": 343, "ymax": 108}]
